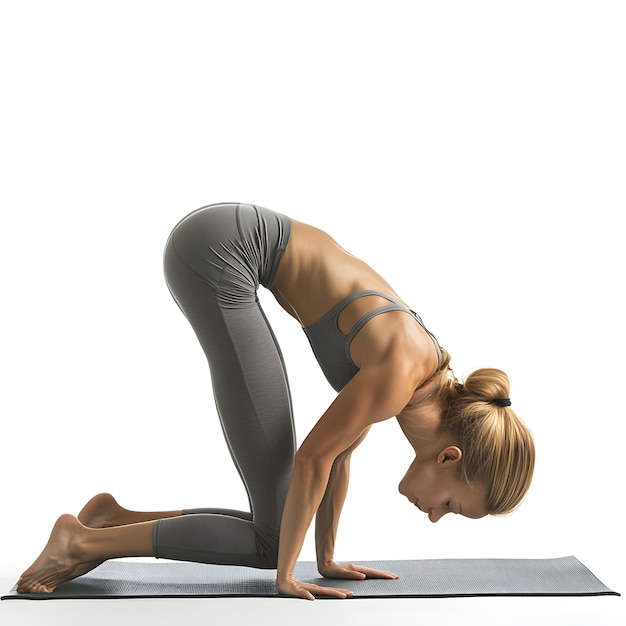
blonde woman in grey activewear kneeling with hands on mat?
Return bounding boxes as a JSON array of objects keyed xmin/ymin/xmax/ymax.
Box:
[{"xmin": 18, "ymin": 204, "xmax": 534, "ymax": 599}]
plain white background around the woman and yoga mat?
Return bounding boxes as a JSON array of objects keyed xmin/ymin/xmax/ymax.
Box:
[{"xmin": 0, "ymin": 0, "xmax": 626, "ymax": 623}]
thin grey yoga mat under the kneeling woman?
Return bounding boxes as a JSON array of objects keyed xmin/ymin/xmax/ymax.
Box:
[{"xmin": 2, "ymin": 556, "xmax": 619, "ymax": 600}]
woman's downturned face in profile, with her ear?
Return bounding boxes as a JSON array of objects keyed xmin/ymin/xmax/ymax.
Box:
[{"xmin": 399, "ymin": 447, "xmax": 487, "ymax": 523}]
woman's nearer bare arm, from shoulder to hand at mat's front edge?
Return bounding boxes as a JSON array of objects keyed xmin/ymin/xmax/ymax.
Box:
[{"xmin": 276, "ymin": 362, "xmax": 415, "ymax": 600}]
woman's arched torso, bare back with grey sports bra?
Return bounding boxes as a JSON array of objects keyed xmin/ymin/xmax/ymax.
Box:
[{"xmin": 271, "ymin": 221, "xmax": 441, "ymax": 391}]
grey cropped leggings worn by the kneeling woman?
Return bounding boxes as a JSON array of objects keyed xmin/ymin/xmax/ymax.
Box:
[{"xmin": 153, "ymin": 204, "xmax": 295, "ymax": 569}]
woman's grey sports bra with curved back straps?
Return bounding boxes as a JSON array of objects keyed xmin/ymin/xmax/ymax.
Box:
[{"xmin": 304, "ymin": 290, "xmax": 441, "ymax": 392}]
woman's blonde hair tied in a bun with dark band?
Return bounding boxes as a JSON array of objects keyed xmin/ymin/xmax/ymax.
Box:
[{"xmin": 437, "ymin": 350, "xmax": 535, "ymax": 515}]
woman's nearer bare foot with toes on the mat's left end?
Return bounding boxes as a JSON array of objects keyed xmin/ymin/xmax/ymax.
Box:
[{"xmin": 17, "ymin": 515, "xmax": 100, "ymax": 593}]
